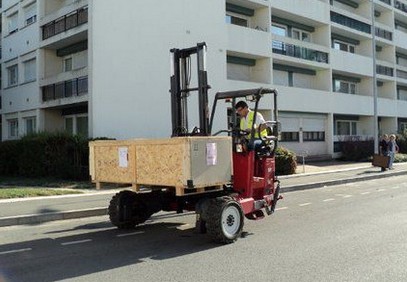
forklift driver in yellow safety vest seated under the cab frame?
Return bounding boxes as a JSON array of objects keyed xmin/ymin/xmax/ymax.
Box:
[{"xmin": 235, "ymin": 101, "xmax": 267, "ymax": 148}]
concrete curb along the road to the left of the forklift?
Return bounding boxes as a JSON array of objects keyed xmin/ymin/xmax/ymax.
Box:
[{"xmin": 0, "ymin": 207, "xmax": 107, "ymax": 227}]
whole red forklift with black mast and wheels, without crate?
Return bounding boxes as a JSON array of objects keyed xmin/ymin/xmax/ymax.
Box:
[{"xmin": 108, "ymin": 43, "xmax": 282, "ymax": 243}]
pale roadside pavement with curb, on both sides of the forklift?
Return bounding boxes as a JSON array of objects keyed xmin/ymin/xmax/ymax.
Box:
[{"xmin": 0, "ymin": 161, "xmax": 407, "ymax": 227}]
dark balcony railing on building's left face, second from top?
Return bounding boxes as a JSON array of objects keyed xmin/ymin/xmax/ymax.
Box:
[{"xmin": 42, "ymin": 76, "xmax": 88, "ymax": 102}]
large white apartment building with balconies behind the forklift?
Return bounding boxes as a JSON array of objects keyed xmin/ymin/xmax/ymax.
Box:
[{"xmin": 0, "ymin": 0, "xmax": 407, "ymax": 157}]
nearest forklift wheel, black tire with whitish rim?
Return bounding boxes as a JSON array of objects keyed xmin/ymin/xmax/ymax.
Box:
[{"xmin": 206, "ymin": 196, "xmax": 244, "ymax": 244}]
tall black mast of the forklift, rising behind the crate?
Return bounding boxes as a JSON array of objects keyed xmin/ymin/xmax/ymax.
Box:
[{"xmin": 170, "ymin": 42, "xmax": 210, "ymax": 137}]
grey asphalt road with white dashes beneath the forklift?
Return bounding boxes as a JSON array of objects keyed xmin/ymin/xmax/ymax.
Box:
[{"xmin": 0, "ymin": 176, "xmax": 407, "ymax": 282}]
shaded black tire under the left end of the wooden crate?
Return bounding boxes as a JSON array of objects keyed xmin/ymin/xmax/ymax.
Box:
[{"xmin": 108, "ymin": 191, "xmax": 152, "ymax": 229}]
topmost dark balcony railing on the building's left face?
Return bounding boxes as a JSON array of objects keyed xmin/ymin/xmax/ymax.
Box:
[{"xmin": 42, "ymin": 7, "xmax": 88, "ymax": 40}]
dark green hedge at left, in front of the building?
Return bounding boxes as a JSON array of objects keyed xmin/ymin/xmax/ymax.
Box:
[{"xmin": 0, "ymin": 133, "xmax": 89, "ymax": 180}]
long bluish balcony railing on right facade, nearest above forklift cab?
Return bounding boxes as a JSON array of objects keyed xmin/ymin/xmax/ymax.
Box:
[{"xmin": 272, "ymin": 40, "xmax": 328, "ymax": 64}]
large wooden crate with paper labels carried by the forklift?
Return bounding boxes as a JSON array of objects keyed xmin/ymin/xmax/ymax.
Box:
[{"xmin": 89, "ymin": 136, "xmax": 232, "ymax": 195}]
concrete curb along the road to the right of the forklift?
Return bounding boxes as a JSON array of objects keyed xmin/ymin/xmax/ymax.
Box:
[{"xmin": 281, "ymin": 171, "xmax": 406, "ymax": 193}]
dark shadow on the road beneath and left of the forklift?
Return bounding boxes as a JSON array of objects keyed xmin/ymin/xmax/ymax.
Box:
[{"xmin": 0, "ymin": 217, "xmax": 233, "ymax": 282}]
